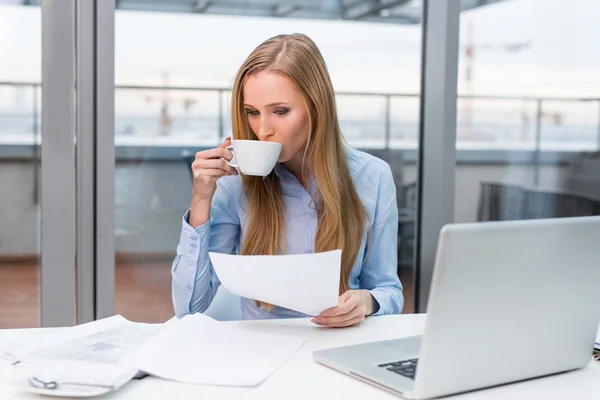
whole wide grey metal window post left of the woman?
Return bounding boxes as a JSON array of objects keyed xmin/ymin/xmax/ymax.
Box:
[{"xmin": 40, "ymin": 0, "xmax": 115, "ymax": 327}]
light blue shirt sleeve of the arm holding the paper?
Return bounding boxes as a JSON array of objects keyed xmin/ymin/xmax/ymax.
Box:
[{"xmin": 359, "ymin": 166, "xmax": 404, "ymax": 315}]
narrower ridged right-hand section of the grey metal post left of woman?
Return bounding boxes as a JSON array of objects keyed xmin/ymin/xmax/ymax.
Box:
[{"xmin": 77, "ymin": 0, "xmax": 115, "ymax": 323}]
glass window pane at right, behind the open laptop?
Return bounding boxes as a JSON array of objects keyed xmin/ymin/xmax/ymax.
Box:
[{"xmin": 455, "ymin": 0, "xmax": 600, "ymax": 222}]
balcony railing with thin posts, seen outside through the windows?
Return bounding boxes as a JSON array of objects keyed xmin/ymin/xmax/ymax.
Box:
[{"xmin": 0, "ymin": 82, "xmax": 600, "ymax": 170}]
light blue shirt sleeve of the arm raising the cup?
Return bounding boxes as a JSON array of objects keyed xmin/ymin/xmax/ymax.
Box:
[{"xmin": 171, "ymin": 177, "xmax": 240, "ymax": 318}]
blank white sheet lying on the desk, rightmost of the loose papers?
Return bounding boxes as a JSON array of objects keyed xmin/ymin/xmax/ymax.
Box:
[{"xmin": 125, "ymin": 314, "xmax": 306, "ymax": 386}]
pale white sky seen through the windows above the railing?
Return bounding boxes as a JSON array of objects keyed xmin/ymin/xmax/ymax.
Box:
[{"xmin": 0, "ymin": 0, "xmax": 600, "ymax": 103}]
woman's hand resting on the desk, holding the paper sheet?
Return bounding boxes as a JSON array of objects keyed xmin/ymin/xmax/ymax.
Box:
[{"xmin": 312, "ymin": 290, "xmax": 375, "ymax": 328}]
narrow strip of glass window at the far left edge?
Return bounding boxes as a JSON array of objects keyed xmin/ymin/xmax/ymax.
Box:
[{"xmin": 0, "ymin": 2, "xmax": 42, "ymax": 328}]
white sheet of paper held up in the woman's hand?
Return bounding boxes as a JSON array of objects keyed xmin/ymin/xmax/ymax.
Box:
[{"xmin": 209, "ymin": 250, "xmax": 342, "ymax": 316}]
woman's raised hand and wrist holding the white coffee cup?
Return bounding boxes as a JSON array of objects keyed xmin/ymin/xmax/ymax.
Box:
[{"xmin": 189, "ymin": 138, "xmax": 238, "ymax": 227}]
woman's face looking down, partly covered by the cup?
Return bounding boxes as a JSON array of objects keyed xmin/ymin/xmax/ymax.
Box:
[{"xmin": 243, "ymin": 71, "xmax": 309, "ymax": 163}]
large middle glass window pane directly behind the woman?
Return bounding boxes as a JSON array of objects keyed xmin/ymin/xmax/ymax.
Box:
[{"xmin": 115, "ymin": 2, "xmax": 436, "ymax": 321}]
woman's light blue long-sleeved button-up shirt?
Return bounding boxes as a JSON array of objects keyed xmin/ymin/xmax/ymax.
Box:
[{"xmin": 171, "ymin": 147, "xmax": 404, "ymax": 319}]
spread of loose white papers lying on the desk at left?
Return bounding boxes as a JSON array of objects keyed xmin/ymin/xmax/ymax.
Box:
[{"xmin": 0, "ymin": 314, "xmax": 306, "ymax": 397}]
